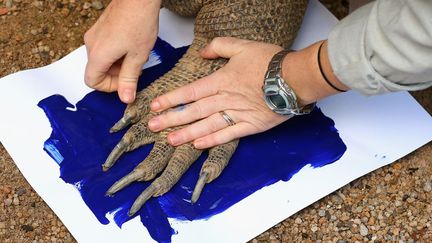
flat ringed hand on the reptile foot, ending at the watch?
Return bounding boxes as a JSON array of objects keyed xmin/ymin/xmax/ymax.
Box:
[{"xmin": 148, "ymin": 37, "xmax": 288, "ymax": 149}]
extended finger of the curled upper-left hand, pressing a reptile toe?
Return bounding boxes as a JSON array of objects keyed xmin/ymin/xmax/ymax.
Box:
[{"xmin": 117, "ymin": 54, "xmax": 146, "ymax": 104}]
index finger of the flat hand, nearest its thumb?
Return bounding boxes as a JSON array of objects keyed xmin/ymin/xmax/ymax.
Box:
[{"xmin": 150, "ymin": 70, "xmax": 223, "ymax": 112}]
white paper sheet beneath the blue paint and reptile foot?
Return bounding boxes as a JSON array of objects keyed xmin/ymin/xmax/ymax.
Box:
[{"xmin": 0, "ymin": 1, "xmax": 432, "ymax": 243}]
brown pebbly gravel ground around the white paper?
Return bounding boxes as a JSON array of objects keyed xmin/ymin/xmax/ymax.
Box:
[{"xmin": 0, "ymin": 0, "xmax": 432, "ymax": 242}]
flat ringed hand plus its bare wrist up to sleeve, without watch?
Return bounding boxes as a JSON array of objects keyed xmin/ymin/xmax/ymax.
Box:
[{"xmin": 148, "ymin": 37, "xmax": 347, "ymax": 149}]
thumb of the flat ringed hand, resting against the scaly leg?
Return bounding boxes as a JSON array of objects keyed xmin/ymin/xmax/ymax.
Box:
[{"xmin": 201, "ymin": 37, "xmax": 251, "ymax": 59}]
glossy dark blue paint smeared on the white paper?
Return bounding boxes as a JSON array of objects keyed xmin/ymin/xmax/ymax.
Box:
[{"xmin": 38, "ymin": 39, "xmax": 346, "ymax": 242}]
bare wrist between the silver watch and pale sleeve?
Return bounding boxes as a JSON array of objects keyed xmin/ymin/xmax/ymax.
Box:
[{"xmin": 282, "ymin": 42, "xmax": 349, "ymax": 105}]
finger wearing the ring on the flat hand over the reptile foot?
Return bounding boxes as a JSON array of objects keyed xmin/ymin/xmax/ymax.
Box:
[{"xmin": 167, "ymin": 111, "xmax": 236, "ymax": 146}]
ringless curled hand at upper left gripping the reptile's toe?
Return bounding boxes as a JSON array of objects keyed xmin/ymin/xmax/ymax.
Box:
[{"xmin": 84, "ymin": 0, "xmax": 161, "ymax": 103}]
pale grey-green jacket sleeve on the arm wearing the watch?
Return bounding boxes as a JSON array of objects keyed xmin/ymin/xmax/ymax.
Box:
[{"xmin": 328, "ymin": 0, "xmax": 432, "ymax": 95}]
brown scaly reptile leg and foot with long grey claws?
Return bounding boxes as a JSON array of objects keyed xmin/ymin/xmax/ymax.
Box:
[{"xmin": 103, "ymin": 0, "xmax": 307, "ymax": 216}]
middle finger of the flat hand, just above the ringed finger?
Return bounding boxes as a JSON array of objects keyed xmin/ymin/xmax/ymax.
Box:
[{"xmin": 149, "ymin": 94, "xmax": 230, "ymax": 132}]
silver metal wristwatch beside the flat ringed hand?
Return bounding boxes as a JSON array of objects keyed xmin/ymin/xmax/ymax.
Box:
[{"xmin": 262, "ymin": 50, "xmax": 315, "ymax": 117}]
